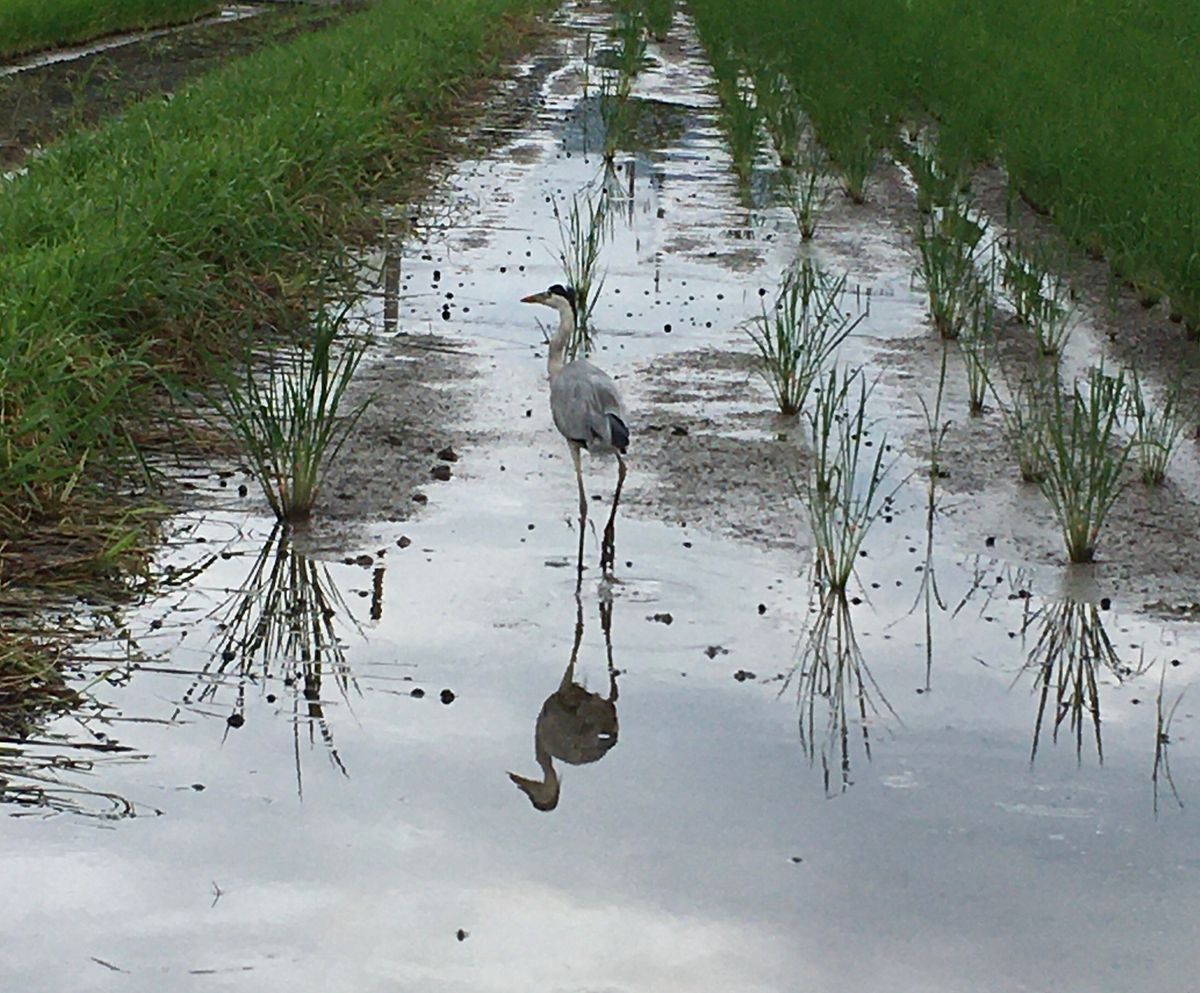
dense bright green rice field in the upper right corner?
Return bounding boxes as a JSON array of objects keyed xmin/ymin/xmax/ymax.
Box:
[{"xmin": 691, "ymin": 0, "xmax": 1200, "ymax": 329}]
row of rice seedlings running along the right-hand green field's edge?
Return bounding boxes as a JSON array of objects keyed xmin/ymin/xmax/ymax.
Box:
[{"xmin": 907, "ymin": 130, "xmax": 1187, "ymax": 562}]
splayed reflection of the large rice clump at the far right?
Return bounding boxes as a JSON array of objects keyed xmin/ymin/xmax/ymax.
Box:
[{"xmin": 1025, "ymin": 600, "xmax": 1140, "ymax": 762}]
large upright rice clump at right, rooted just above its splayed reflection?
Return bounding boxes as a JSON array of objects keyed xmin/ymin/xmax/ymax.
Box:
[{"xmin": 1040, "ymin": 368, "xmax": 1133, "ymax": 562}]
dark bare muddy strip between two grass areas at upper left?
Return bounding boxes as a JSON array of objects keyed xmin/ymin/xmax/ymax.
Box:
[{"xmin": 0, "ymin": 5, "xmax": 341, "ymax": 168}]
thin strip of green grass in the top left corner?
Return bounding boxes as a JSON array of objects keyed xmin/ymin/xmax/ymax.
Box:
[{"xmin": 0, "ymin": 0, "xmax": 221, "ymax": 59}]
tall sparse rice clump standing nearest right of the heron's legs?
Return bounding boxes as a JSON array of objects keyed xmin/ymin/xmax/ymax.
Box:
[{"xmin": 800, "ymin": 368, "xmax": 890, "ymax": 591}]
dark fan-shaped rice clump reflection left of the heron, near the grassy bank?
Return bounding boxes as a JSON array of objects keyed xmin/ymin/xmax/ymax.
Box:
[{"xmin": 180, "ymin": 525, "xmax": 358, "ymax": 789}]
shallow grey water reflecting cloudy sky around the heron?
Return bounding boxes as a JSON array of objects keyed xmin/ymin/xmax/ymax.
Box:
[{"xmin": 0, "ymin": 8, "xmax": 1200, "ymax": 993}]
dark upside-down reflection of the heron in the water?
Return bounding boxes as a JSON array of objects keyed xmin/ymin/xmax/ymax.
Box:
[{"xmin": 509, "ymin": 596, "xmax": 618, "ymax": 811}]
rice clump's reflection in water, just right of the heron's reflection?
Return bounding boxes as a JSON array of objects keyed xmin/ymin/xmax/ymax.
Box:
[{"xmin": 785, "ymin": 590, "xmax": 895, "ymax": 794}]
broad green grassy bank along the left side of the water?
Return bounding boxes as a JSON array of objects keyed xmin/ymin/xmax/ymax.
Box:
[{"xmin": 0, "ymin": 0, "xmax": 547, "ymax": 583}]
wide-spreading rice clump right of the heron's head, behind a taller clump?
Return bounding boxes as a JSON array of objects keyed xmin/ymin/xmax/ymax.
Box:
[{"xmin": 748, "ymin": 259, "xmax": 865, "ymax": 416}]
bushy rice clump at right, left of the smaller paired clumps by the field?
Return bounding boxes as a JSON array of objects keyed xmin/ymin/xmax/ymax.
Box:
[{"xmin": 916, "ymin": 205, "xmax": 982, "ymax": 339}]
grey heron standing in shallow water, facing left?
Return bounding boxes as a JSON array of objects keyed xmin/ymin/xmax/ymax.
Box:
[{"xmin": 521, "ymin": 283, "xmax": 629, "ymax": 578}]
